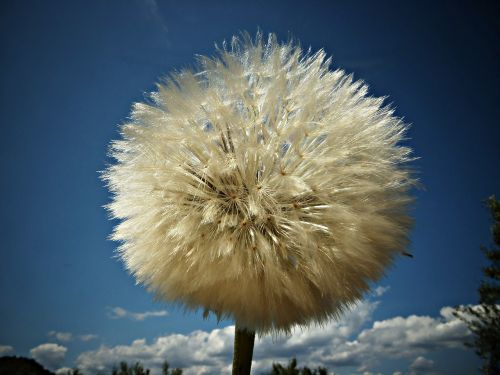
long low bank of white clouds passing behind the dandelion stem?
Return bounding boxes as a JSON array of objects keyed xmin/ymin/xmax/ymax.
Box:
[{"xmin": 76, "ymin": 300, "xmax": 470, "ymax": 375}]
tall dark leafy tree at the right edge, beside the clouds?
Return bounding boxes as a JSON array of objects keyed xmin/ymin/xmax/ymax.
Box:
[{"xmin": 454, "ymin": 195, "xmax": 500, "ymax": 375}]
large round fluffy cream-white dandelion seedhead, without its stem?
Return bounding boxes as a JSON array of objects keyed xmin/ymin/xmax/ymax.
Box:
[{"xmin": 104, "ymin": 30, "xmax": 414, "ymax": 333}]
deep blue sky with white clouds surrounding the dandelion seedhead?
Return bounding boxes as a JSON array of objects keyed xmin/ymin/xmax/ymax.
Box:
[{"xmin": 0, "ymin": 0, "xmax": 500, "ymax": 374}]
